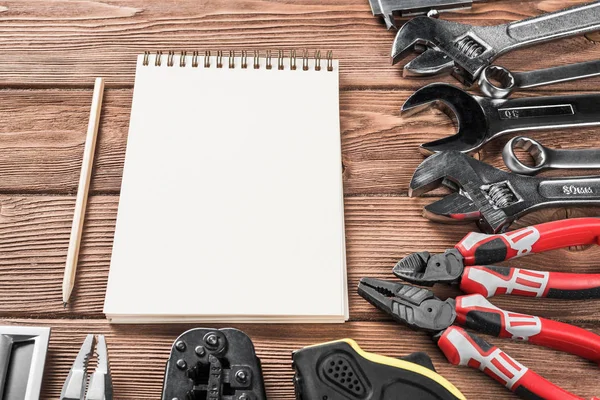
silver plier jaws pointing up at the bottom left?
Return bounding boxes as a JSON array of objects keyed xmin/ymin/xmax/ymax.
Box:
[{"xmin": 60, "ymin": 335, "xmax": 113, "ymax": 400}]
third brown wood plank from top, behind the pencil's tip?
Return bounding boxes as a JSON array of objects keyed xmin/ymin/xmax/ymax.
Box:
[{"xmin": 0, "ymin": 195, "xmax": 600, "ymax": 321}]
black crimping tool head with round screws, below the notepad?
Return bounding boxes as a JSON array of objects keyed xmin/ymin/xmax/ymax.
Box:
[{"xmin": 162, "ymin": 328, "xmax": 267, "ymax": 400}]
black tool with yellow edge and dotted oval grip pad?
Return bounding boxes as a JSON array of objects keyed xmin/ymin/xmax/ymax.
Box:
[{"xmin": 292, "ymin": 339, "xmax": 465, "ymax": 400}]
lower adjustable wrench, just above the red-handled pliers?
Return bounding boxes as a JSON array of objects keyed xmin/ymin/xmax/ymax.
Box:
[{"xmin": 409, "ymin": 151, "xmax": 600, "ymax": 233}]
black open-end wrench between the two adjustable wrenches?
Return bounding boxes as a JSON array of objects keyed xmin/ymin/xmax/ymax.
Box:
[{"xmin": 402, "ymin": 83, "xmax": 600, "ymax": 154}]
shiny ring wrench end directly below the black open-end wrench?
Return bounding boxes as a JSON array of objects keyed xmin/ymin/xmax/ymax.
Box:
[{"xmin": 502, "ymin": 136, "xmax": 600, "ymax": 175}]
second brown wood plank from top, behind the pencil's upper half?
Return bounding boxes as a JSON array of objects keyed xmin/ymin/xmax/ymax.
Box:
[{"xmin": 0, "ymin": 86, "xmax": 600, "ymax": 195}]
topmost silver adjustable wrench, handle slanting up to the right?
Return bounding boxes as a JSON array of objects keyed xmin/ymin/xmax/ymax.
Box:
[{"xmin": 392, "ymin": 1, "xmax": 600, "ymax": 86}]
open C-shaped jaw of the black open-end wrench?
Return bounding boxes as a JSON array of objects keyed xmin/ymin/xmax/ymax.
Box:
[{"xmin": 402, "ymin": 83, "xmax": 490, "ymax": 154}]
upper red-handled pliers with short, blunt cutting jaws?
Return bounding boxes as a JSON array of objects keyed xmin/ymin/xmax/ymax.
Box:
[{"xmin": 393, "ymin": 218, "xmax": 600, "ymax": 300}]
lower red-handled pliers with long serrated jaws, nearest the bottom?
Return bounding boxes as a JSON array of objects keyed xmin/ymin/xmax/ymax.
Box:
[{"xmin": 358, "ymin": 278, "xmax": 600, "ymax": 400}]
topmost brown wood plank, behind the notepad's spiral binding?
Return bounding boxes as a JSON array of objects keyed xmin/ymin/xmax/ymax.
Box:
[{"xmin": 0, "ymin": 0, "xmax": 598, "ymax": 88}]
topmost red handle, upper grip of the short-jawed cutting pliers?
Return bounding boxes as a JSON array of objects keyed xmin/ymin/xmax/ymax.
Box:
[{"xmin": 455, "ymin": 218, "xmax": 600, "ymax": 265}]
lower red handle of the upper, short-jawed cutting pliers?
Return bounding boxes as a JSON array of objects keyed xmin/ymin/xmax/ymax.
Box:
[{"xmin": 460, "ymin": 266, "xmax": 600, "ymax": 300}]
